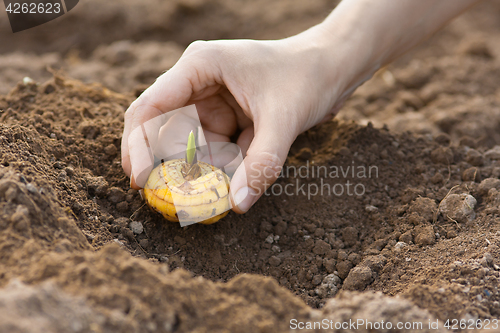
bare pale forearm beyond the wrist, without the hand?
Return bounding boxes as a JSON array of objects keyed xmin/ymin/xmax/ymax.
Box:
[{"xmin": 306, "ymin": 0, "xmax": 479, "ymax": 97}]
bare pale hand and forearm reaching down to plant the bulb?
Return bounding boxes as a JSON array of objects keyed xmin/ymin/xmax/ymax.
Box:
[{"xmin": 122, "ymin": 0, "xmax": 479, "ymax": 213}]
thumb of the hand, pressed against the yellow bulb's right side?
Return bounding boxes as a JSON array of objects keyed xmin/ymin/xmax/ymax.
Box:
[{"xmin": 230, "ymin": 122, "xmax": 295, "ymax": 214}]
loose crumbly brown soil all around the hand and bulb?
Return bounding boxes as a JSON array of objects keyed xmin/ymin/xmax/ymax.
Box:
[{"xmin": 0, "ymin": 0, "xmax": 500, "ymax": 332}]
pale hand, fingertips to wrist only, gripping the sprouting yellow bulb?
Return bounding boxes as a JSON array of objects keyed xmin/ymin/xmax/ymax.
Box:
[{"xmin": 122, "ymin": 28, "xmax": 356, "ymax": 213}]
